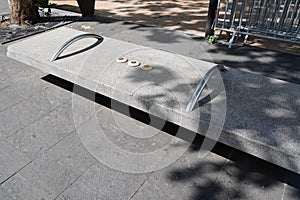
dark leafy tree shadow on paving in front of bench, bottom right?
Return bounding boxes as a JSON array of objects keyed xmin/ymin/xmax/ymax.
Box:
[{"xmin": 167, "ymin": 145, "xmax": 300, "ymax": 200}]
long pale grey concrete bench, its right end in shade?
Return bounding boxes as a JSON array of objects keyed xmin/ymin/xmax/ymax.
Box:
[{"xmin": 7, "ymin": 27, "xmax": 300, "ymax": 173}]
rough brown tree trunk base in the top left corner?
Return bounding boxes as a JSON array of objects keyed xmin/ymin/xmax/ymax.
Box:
[{"xmin": 8, "ymin": 0, "xmax": 40, "ymax": 25}]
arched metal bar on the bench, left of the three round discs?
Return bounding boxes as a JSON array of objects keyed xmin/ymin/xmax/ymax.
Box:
[{"xmin": 50, "ymin": 33, "xmax": 103, "ymax": 62}]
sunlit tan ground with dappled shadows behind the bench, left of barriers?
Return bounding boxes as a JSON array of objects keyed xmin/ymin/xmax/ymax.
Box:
[{"xmin": 52, "ymin": 0, "xmax": 209, "ymax": 33}]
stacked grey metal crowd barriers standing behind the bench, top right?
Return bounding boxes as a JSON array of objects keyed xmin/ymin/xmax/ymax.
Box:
[{"xmin": 214, "ymin": 0, "xmax": 300, "ymax": 48}]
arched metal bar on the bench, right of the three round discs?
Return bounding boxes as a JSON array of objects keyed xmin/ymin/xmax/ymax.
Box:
[{"xmin": 185, "ymin": 65, "xmax": 225, "ymax": 112}]
